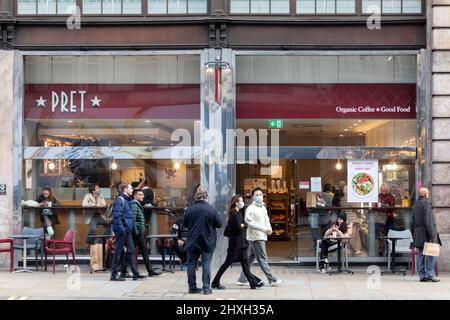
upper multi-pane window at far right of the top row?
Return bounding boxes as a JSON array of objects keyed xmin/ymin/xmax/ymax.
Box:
[{"xmin": 362, "ymin": 0, "xmax": 422, "ymax": 14}]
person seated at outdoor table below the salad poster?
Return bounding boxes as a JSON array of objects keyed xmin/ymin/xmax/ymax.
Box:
[{"xmin": 319, "ymin": 213, "xmax": 348, "ymax": 273}]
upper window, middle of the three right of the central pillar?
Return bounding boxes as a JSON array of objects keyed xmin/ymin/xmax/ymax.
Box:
[{"xmin": 297, "ymin": 0, "xmax": 355, "ymax": 14}]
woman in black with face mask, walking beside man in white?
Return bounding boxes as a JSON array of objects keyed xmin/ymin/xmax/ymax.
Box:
[{"xmin": 211, "ymin": 195, "xmax": 264, "ymax": 290}]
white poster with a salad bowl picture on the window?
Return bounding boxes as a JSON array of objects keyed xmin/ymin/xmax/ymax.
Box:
[{"xmin": 347, "ymin": 160, "xmax": 378, "ymax": 203}]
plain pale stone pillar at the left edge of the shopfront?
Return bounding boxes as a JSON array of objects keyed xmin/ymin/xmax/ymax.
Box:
[{"xmin": 0, "ymin": 50, "xmax": 14, "ymax": 268}]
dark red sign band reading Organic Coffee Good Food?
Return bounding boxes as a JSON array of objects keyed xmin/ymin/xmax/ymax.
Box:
[{"xmin": 236, "ymin": 83, "xmax": 416, "ymax": 119}]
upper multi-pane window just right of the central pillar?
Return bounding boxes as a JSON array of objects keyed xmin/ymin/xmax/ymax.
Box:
[{"xmin": 230, "ymin": 0, "xmax": 289, "ymax": 14}]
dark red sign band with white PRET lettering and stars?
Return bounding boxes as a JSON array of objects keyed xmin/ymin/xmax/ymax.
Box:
[{"xmin": 25, "ymin": 84, "xmax": 200, "ymax": 120}]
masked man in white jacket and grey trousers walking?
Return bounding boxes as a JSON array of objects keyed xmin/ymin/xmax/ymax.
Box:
[{"xmin": 237, "ymin": 187, "xmax": 283, "ymax": 286}]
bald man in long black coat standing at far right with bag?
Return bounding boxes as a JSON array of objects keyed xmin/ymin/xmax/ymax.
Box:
[{"xmin": 412, "ymin": 188, "xmax": 440, "ymax": 282}]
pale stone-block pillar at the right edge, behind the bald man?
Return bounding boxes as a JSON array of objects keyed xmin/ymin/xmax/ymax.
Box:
[{"xmin": 428, "ymin": 0, "xmax": 450, "ymax": 271}]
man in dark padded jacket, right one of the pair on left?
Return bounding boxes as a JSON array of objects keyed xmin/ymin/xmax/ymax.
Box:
[{"xmin": 121, "ymin": 190, "xmax": 161, "ymax": 278}]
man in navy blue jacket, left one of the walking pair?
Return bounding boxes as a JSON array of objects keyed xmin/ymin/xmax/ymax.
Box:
[{"xmin": 110, "ymin": 183, "xmax": 145, "ymax": 281}]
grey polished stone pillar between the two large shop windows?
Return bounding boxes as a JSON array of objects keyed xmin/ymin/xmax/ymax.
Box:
[{"xmin": 200, "ymin": 49, "xmax": 236, "ymax": 268}]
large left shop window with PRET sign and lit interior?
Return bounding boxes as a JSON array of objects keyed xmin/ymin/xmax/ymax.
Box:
[{"xmin": 23, "ymin": 55, "xmax": 200, "ymax": 254}]
